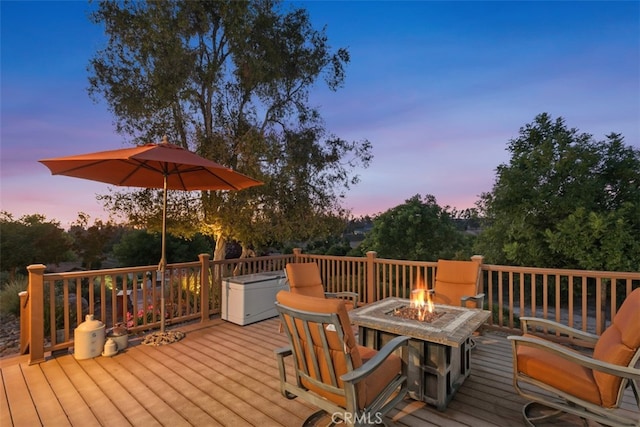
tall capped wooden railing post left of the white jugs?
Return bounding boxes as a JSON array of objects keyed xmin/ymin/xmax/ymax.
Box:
[{"xmin": 26, "ymin": 264, "xmax": 46, "ymax": 365}]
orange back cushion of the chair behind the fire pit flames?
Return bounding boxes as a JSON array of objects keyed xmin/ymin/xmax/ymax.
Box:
[{"xmin": 434, "ymin": 259, "xmax": 480, "ymax": 308}]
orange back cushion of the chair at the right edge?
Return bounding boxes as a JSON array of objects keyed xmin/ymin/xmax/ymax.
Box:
[{"xmin": 593, "ymin": 288, "xmax": 640, "ymax": 407}]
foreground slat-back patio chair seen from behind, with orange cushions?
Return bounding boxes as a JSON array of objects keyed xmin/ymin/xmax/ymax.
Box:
[{"xmin": 276, "ymin": 291, "xmax": 409, "ymax": 426}]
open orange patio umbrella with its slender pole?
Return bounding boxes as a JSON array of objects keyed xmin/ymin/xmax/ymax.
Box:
[{"xmin": 39, "ymin": 137, "xmax": 262, "ymax": 332}]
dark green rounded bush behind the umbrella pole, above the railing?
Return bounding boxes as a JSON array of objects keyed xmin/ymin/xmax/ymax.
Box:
[{"xmin": 113, "ymin": 230, "xmax": 212, "ymax": 267}]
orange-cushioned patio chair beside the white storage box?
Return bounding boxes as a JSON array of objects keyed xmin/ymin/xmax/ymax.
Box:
[{"xmin": 285, "ymin": 262, "xmax": 359, "ymax": 310}]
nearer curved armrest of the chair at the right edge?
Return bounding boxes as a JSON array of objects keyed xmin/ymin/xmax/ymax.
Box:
[{"xmin": 507, "ymin": 335, "xmax": 640, "ymax": 381}]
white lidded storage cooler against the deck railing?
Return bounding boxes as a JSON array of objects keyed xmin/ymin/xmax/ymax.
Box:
[{"xmin": 221, "ymin": 271, "xmax": 289, "ymax": 325}]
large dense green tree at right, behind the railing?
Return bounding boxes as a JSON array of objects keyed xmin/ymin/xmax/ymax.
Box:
[{"xmin": 476, "ymin": 113, "xmax": 640, "ymax": 271}]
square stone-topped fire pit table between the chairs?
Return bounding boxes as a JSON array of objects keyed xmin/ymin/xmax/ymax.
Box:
[{"xmin": 349, "ymin": 298, "xmax": 491, "ymax": 411}]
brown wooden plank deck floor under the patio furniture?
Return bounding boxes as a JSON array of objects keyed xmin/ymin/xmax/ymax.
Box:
[{"xmin": 0, "ymin": 319, "xmax": 632, "ymax": 427}]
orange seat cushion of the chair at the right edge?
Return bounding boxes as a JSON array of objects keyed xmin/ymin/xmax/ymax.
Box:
[{"xmin": 516, "ymin": 334, "xmax": 601, "ymax": 405}]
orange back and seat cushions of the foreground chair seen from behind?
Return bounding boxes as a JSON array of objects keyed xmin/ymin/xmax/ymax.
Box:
[{"xmin": 276, "ymin": 291, "xmax": 402, "ymax": 409}]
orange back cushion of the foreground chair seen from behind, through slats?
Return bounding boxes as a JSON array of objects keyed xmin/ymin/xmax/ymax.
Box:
[{"xmin": 276, "ymin": 290, "xmax": 366, "ymax": 407}]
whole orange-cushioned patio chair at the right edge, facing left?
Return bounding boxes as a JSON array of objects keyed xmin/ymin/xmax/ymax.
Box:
[{"xmin": 509, "ymin": 288, "xmax": 640, "ymax": 426}]
